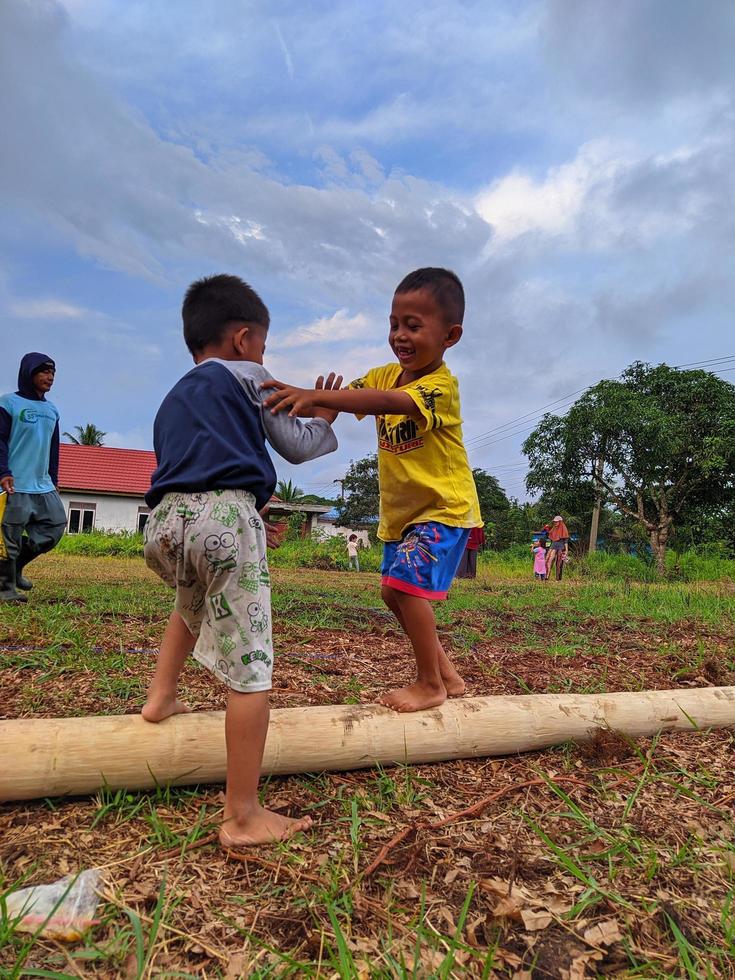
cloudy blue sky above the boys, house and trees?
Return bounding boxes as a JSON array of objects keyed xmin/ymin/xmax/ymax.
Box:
[{"xmin": 0, "ymin": 0, "xmax": 735, "ymax": 499}]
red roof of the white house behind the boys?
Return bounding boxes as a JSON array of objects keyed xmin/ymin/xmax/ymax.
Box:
[{"xmin": 59, "ymin": 442, "xmax": 156, "ymax": 497}]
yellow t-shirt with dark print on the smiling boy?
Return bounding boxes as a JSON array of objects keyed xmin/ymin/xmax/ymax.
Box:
[{"xmin": 349, "ymin": 364, "xmax": 482, "ymax": 541}]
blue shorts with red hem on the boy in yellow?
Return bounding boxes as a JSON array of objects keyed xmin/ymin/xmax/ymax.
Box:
[{"xmin": 380, "ymin": 521, "xmax": 470, "ymax": 599}]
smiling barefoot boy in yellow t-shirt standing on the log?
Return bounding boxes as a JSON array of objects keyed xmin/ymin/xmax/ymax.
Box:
[{"xmin": 263, "ymin": 268, "xmax": 482, "ymax": 711}]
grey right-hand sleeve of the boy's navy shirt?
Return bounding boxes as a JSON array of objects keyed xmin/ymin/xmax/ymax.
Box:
[{"xmin": 227, "ymin": 361, "xmax": 337, "ymax": 463}]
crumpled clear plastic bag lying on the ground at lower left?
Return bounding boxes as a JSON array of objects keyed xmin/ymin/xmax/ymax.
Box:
[{"xmin": 5, "ymin": 868, "xmax": 100, "ymax": 943}]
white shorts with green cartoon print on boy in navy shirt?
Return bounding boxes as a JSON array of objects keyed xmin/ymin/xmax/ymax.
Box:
[{"xmin": 143, "ymin": 490, "xmax": 273, "ymax": 694}]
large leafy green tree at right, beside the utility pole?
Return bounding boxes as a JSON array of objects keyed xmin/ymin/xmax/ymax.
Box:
[{"xmin": 523, "ymin": 361, "xmax": 735, "ymax": 572}]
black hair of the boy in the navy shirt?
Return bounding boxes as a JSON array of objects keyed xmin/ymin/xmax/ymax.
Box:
[{"xmin": 181, "ymin": 275, "xmax": 271, "ymax": 354}]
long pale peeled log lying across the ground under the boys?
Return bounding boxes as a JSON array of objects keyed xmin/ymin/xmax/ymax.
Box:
[{"xmin": 0, "ymin": 687, "xmax": 735, "ymax": 801}]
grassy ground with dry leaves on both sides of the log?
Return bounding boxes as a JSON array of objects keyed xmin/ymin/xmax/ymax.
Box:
[{"xmin": 0, "ymin": 554, "xmax": 735, "ymax": 980}]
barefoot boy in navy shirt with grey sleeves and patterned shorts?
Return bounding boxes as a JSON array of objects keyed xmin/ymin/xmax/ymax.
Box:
[{"xmin": 142, "ymin": 275, "xmax": 337, "ymax": 848}]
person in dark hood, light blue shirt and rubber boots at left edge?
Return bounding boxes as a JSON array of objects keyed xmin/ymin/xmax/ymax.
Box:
[{"xmin": 0, "ymin": 351, "xmax": 66, "ymax": 602}]
